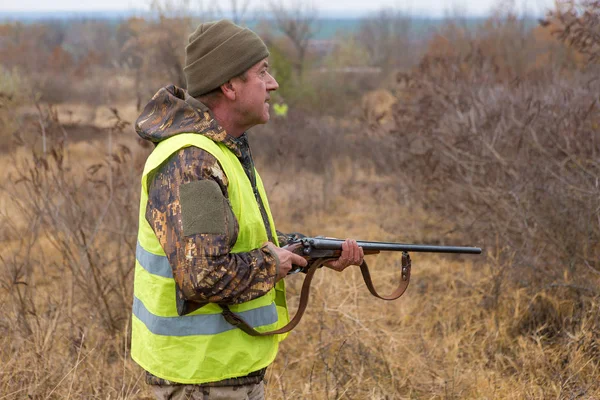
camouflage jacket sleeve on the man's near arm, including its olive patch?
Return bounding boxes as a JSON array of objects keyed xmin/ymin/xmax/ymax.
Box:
[{"xmin": 146, "ymin": 147, "xmax": 278, "ymax": 304}]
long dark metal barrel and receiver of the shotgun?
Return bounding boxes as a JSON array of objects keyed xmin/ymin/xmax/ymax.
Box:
[{"xmin": 302, "ymin": 238, "xmax": 481, "ymax": 254}]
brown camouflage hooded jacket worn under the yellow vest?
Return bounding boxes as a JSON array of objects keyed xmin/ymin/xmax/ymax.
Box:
[{"xmin": 136, "ymin": 86, "xmax": 298, "ymax": 315}]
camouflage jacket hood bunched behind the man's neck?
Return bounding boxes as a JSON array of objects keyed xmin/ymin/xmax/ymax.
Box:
[{"xmin": 135, "ymin": 85, "xmax": 239, "ymax": 155}]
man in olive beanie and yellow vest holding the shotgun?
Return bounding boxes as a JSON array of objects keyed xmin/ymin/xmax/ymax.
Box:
[{"xmin": 131, "ymin": 21, "xmax": 363, "ymax": 399}]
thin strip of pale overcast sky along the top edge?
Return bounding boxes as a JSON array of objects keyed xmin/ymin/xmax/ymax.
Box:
[{"xmin": 0, "ymin": 0, "xmax": 554, "ymax": 16}]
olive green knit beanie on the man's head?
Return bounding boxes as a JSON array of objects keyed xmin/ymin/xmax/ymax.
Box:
[{"xmin": 183, "ymin": 20, "xmax": 269, "ymax": 97}]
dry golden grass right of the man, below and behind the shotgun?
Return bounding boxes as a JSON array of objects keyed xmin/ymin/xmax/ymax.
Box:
[{"xmin": 268, "ymin": 171, "xmax": 600, "ymax": 399}]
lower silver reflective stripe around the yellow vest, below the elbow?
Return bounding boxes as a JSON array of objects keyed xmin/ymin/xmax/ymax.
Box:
[{"xmin": 133, "ymin": 297, "xmax": 277, "ymax": 336}]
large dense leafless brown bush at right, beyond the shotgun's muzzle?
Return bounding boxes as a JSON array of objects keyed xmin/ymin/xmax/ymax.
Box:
[{"xmin": 395, "ymin": 12, "xmax": 600, "ymax": 295}]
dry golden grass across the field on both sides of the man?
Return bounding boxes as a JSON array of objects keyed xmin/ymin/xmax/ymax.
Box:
[{"xmin": 0, "ymin": 135, "xmax": 600, "ymax": 399}]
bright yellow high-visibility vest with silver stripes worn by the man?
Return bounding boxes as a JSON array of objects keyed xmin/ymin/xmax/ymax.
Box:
[{"xmin": 131, "ymin": 133, "xmax": 289, "ymax": 384}]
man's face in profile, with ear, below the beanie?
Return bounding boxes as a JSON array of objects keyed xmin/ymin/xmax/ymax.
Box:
[{"xmin": 231, "ymin": 59, "xmax": 279, "ymax": 126}]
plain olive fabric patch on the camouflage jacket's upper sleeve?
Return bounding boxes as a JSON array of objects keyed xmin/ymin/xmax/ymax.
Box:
[{"xmin": 179, "ymin": 180, "xmax": 233, "ymax": 236}]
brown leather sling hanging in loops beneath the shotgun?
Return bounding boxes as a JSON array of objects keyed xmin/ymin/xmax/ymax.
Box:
[{"xmin": 220, "ymin": 252, "xmax": 411, "ymax": 336}]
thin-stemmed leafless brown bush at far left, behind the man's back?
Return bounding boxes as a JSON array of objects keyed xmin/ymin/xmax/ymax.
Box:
[{"xmin": 3, "ymin": 102, "xmax": 137, "ymax": 333}]
